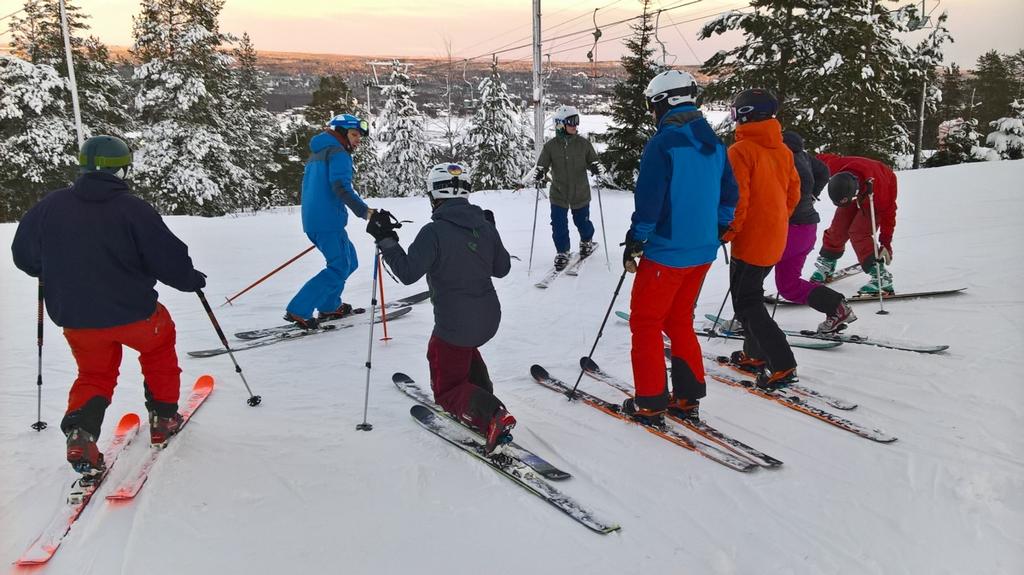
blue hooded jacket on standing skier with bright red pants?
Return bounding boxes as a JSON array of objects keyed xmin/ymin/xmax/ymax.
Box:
[{"xmin": 631, "ymin": 105, "xmax": 739, "ymax": 268}]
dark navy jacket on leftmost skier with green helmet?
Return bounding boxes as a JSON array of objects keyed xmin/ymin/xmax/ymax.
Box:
[{"xmin": 10, "ymin": 172, "xmax": 206, "ymax": 328}]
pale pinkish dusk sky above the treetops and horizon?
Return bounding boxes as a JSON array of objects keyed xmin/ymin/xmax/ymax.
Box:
[{"xmin": 0, "ymin": 0, "xmax": 1024, "ymax": 68}]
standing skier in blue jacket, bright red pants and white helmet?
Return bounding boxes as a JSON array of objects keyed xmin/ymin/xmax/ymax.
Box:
[{"xmin": 623, "ymin": 70, "xmax": 738, "ymax": 424}]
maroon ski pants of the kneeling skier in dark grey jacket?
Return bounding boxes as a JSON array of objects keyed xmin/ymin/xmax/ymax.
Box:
[{"xmin": 427, "ymin": 336, "xmax": 503, "ymax": 432}]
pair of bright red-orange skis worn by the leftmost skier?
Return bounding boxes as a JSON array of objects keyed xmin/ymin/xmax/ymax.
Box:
[{"xmin": 14, "ymin": 375, "xmax": 214, "ymax": 567}]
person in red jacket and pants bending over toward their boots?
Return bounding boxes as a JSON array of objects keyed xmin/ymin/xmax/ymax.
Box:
[{"xmin": 811, "ymin": 153, "xmax": 896, "ymax": 294}]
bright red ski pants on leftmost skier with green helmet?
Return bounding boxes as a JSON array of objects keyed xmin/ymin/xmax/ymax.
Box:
[{"xmin": 63, "ymin": 303, "xmax": 181, "ymax": 412}]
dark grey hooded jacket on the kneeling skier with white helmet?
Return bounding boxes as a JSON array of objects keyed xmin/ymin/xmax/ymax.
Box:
[{"xmin": 378, "ymin": 197, "xmax": 512, "ymax": 348}]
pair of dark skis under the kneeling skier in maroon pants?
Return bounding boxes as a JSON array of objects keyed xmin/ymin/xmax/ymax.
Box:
[{"xmin": 391, "ymin": 373, "xmax": 620, "ymax": 534}]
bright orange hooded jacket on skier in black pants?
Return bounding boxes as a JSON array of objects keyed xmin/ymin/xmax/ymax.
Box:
[{"xmin": 722, "ymin": 120, "xmax": 800, "ymax": 266}]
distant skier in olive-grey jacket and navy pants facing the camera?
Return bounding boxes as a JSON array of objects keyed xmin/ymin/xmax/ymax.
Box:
[{"xmin": 532, "ymin": 105, "xmax": 601, "ymax": 269}]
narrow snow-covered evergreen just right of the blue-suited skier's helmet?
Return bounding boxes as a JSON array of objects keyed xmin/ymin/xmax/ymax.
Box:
[{"xmin": 378, "ymin": 60, "xmax": 431, "ymax": 197}]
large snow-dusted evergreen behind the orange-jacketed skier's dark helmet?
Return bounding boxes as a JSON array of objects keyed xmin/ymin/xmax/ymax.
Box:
[{"xmin": 701, "ymin": 0, "xmax": 920, "ymax": 162}]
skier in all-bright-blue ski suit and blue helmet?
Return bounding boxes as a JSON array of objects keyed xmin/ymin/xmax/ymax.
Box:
[{"xmin": 285, "ymin": 114, "xmax": 373, "ymax": 329}]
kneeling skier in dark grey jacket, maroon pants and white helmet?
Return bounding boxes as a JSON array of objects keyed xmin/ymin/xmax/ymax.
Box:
[{"xmin": 367, "ymin": 164, "xmax": 515, "ymax": 452}]
